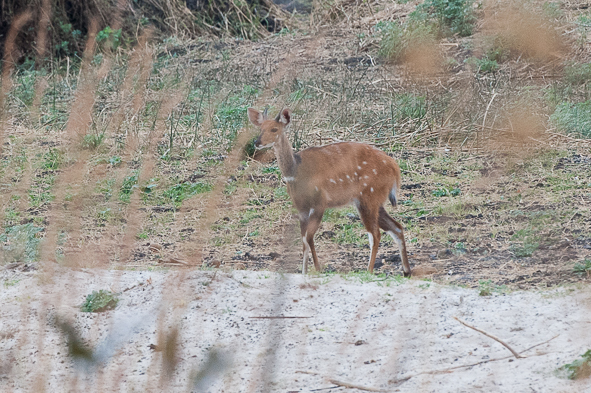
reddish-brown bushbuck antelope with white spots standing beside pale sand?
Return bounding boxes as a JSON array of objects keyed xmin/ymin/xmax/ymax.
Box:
[{"xmin": 248, "ymin": 108, "xmax": 410, "ymax": 276}]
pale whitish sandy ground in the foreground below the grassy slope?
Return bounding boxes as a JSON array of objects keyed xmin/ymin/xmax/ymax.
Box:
[{"xmin": 0, "ymin": 266, "xmax": 591, "ymax": 392}]
